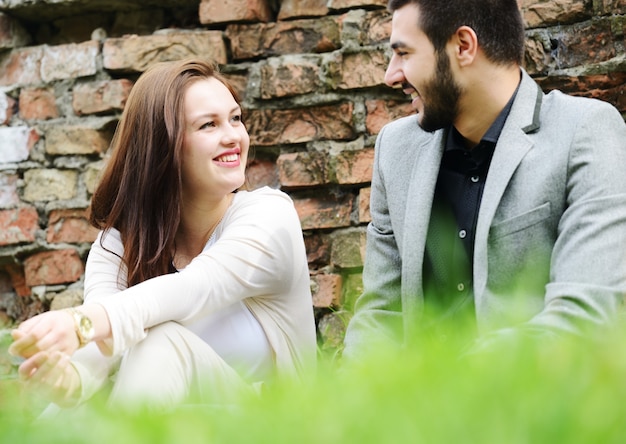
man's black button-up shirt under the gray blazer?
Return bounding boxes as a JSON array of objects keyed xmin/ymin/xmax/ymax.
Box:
[{"xmin": 423, "ymin": 87, "xmax": 517, "ymax": 322}]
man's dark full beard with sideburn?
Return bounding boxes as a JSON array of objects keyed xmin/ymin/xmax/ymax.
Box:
[{"xmin": 419, "ymin": 50, "xmax": 462, "ymax": 132}]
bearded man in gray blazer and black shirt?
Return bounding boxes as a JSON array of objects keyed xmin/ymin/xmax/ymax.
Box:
[{"xmin": 344, "ymin": 0, "xmax": 626, "ymax": 359}]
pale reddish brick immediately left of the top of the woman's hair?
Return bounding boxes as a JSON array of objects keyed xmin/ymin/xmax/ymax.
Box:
[{"xmin": 72, "ymin": 79, "xmax": 133, "ymax": 116}]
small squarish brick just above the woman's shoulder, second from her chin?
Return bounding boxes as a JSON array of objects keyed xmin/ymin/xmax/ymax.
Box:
[{"xmin": 276, "ymin": 151, "xmax": 327, "ymax": 187}]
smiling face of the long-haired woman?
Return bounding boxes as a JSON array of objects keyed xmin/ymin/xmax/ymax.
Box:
[{"xmin": 182, "ymin": 77, "xmax": 250, "ymax": 199}]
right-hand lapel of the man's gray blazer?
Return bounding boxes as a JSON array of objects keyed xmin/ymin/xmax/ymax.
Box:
[{"xmin": 474, "ymin": 70, "xmax": 543, "ymax": 296}]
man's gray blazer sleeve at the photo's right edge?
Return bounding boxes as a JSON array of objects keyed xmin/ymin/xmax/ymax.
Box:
[{"xmin": 530, "ymin": 100, "xmax": 626, "ymax": 333}]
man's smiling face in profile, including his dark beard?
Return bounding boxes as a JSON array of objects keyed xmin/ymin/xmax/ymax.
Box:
[{"xmin": 385, "ymin": 4, "xmax": 462, "ymax": 131}]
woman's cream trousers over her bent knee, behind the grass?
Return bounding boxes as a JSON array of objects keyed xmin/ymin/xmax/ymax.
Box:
[{"xmin": 40, "ymin": 322, "xmax": 254, "ymax": 419}]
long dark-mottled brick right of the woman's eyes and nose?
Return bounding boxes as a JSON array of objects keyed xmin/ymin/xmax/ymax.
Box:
[{"xmin": 247, "ymin": 103, "xmax": 356, "ymax": 146}]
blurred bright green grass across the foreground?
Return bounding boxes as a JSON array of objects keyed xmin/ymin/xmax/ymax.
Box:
[{"xmin": 0, "ymin": 322, "xmax": 626, "ymax": 444}]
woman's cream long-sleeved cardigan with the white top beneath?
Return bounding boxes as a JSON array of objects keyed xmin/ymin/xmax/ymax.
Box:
[{"xmin": 73, "ymin": 187, "xmax": 316, "ymax": 400}]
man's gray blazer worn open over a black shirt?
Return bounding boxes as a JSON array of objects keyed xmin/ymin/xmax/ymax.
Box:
[{"xmin": 344, "ymin": 71, "xmax": 626, "ymax": 358}]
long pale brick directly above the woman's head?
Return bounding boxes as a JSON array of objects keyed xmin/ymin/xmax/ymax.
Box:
[{"xmin": 102, "ymin": 31, "xmax": 227, "ymax": 72}]
